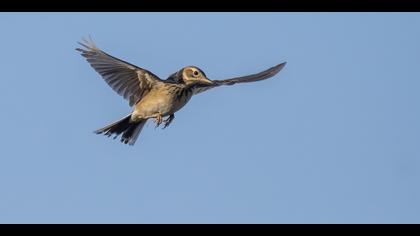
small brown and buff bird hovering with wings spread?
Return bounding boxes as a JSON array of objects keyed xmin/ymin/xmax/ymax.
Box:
[{"xmin": 76, "ymin": 38, "xmax": 286, "ymax": 145}]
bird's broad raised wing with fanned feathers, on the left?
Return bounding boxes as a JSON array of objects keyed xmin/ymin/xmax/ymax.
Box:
[{"xmin": 76, "ymin": 39, "xmax": 161, "ymax": 106}]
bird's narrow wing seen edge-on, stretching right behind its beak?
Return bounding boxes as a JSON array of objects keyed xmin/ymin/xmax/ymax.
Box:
[{"xmin": 193, "ymin": 62, "xmax": 286, "ymax": 94}]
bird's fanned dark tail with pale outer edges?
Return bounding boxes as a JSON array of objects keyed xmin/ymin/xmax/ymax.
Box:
[{"xmin": 95, "ymin": 114, "xmax": 147, "ymax": 145}]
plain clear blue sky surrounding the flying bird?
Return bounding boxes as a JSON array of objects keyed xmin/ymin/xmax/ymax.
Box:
[{"xmin": 0, "ymin": 13, "xmax": 420, "ymax": 223}]
